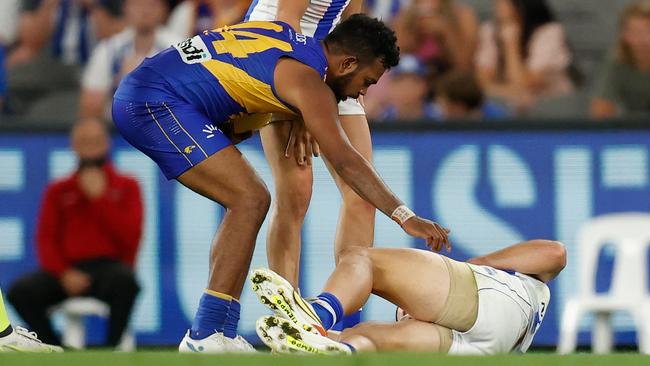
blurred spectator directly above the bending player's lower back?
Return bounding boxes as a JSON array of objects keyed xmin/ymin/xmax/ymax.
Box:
[{"xmin": 167, "ymin": 0, "xmax": 251, "ymax": 37}]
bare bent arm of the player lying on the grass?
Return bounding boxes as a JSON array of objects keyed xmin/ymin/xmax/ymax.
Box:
[{"xmin": 467, "ymin": 239, "xmax": 566, "ymax": 282}]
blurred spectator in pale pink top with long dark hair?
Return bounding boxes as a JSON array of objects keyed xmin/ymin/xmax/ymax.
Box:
[{"xmin": 476, "ymin": 0, "xmax": 573, "ymax": 113}]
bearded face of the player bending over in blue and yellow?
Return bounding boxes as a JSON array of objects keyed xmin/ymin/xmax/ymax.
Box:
[{"xmin": 329, "ymin": 59, "xmax": 386, "ymax": 101}]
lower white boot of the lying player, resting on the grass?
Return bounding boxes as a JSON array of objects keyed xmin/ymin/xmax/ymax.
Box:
[{"xmin": 255, "ymin": 316, "xmax": 352, "ymax": 355}]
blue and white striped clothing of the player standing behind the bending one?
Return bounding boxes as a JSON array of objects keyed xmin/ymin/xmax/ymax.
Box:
[{"xmin": 245, "ymin": 0, "xmax": 350, "ymax": 40}]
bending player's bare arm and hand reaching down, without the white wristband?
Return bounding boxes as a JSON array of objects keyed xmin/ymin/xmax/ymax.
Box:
[{"xmin": 275, "ymin": 59, "xmax": 449, "ymax": 250}]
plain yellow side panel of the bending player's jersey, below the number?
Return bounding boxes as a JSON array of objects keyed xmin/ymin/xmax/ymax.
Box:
[{"xmin": 201, "ymin": 60, "xmax": 295, "ymax": 114}]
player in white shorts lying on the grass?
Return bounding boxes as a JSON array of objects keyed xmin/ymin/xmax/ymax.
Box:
[{"xmin": 251, "ymin": 240, "xmax": 566, "ymax": 354}]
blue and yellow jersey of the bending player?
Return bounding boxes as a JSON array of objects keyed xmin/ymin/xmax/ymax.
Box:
[{"xmin": 115, "ymin": 21, "xmax": 327, "ymax": 125}]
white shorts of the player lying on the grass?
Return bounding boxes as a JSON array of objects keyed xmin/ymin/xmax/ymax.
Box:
[{"xmin": 449, "ymin": 264, "xmax": 533, "ymax": 355}]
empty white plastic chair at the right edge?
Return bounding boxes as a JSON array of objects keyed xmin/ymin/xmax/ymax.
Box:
[{"xmin": 558, "ymin": 212, "xmax": 650, "ymax": 354}]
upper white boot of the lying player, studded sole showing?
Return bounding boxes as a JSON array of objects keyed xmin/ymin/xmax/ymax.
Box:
[{"xmin": 250, "ymin": 268, "xmax": 327, "ymax": 336}]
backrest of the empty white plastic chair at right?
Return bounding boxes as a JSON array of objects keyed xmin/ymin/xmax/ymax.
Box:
[{"xmin": 578, "ymin": 212, "xmax": 650, "ymax": 302}]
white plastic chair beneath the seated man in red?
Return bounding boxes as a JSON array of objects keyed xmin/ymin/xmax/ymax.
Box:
[{"xmin": 55, "ymin": 297, "xmax": 135, "ymax": 352}]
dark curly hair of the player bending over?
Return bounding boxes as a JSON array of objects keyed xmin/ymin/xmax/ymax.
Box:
[{"xmin": 325, "ymin": 14, "xmax": 399, "ymax": 69}]
